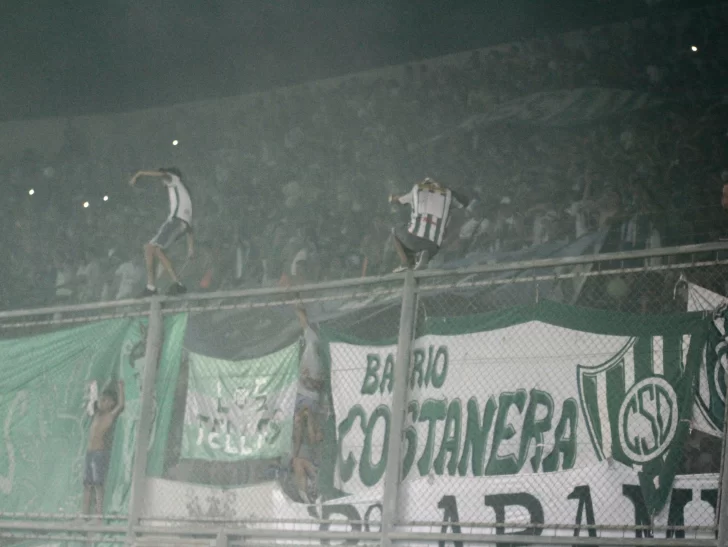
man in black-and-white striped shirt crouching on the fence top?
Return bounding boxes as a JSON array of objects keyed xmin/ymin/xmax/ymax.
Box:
[{"xmin": 389, "ymin": 178, "xmax": 468, "ymax": 273}]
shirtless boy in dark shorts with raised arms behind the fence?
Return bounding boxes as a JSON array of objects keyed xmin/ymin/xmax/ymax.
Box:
[{"xmin": 83, "ymin": 381, "xmax": 124, "ymax": 515}]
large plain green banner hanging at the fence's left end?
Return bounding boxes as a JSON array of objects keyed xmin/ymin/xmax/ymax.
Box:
[{"xmin": 0, "ymin": 316, "xmax": 186, "ymax": 515}]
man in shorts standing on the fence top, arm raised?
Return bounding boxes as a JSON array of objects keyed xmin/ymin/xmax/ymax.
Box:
[{"xmin": 129, "ymin": 167, "xmax": 195, "ymax": 296}]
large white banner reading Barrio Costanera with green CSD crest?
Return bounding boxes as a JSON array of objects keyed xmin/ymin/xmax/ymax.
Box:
[{"xmin": 330, "ymin": 312, "xmax": 700, "ymax": 520}]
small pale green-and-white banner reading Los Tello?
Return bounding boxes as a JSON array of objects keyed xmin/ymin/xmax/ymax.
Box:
[{"xmin": 182, "ymin": 344, "xmax": 298, "ymax": 461}]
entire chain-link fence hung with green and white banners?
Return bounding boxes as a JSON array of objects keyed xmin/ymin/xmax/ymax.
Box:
[{"xmin": 0, "ymin": 246, "xmax": 728, "ymax": 545}]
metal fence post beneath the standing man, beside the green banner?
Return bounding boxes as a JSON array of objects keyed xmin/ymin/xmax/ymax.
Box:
[{"xmin": 127, "ymin": 298, "xmax": 164, "ymax": 545}]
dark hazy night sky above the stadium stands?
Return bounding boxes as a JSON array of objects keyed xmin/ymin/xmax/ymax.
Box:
[{"xmin": 0, "ymin": 0, "xmax": 714, "ymax": 120}]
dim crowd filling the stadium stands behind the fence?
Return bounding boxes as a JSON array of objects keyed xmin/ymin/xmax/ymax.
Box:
[{"xmin": 0, "ymin": 4, "xmax": 728, "ymax": 308}]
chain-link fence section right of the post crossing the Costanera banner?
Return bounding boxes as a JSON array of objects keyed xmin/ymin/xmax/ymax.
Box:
[{"xmin": 399, "ymin": 247, "xmax": 728, "ymax": 541}]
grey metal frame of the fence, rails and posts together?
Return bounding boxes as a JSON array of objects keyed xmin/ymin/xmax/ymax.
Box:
[{"xmin": 0, "ymin": 243, "xmax": 728, "ymax": 546}]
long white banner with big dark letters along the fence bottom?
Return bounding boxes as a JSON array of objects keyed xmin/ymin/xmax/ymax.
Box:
[{"xmin": 144, "ymin": 463, "xmax": 718, "ymax": 545}]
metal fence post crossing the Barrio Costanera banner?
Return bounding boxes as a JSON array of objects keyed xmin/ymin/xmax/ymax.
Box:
[{"xmin": 381, "ymin": 271, "xmax": 417, "ymax": 547}]
